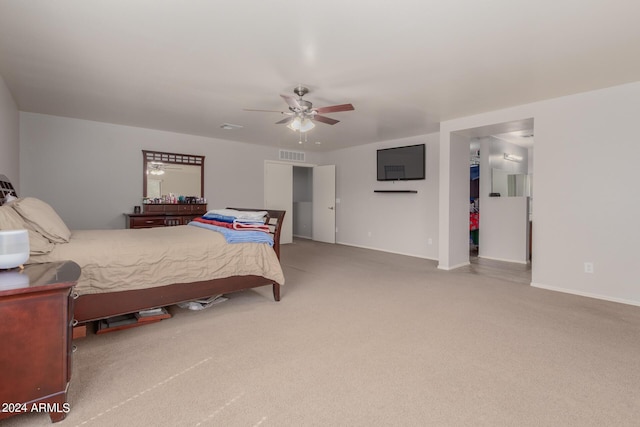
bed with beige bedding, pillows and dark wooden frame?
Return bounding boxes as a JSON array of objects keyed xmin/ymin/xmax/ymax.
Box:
[{"xmin": 0, "ymin": 175, "xmax": 285, "ymax": 323}]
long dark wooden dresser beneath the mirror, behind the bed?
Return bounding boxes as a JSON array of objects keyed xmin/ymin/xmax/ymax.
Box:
[{"xmin": 125, "ymin": 203, "xmax": 207, "ymax": 228}]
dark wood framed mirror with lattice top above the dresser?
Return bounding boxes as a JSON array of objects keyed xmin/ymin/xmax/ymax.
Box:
[{"xmin": 142, "ymin": 150, "xmax": 204, "ymax": 199}]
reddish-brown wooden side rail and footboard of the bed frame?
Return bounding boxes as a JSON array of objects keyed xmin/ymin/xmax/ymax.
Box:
[{"xmin": 74, "ymin": 208, "xmax": 285, "ymax": 323}]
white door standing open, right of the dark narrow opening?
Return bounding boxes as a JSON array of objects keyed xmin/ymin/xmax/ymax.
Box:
[{"xmin": 312, "ymin": 165, "xmax": 336, "ymax": 243}]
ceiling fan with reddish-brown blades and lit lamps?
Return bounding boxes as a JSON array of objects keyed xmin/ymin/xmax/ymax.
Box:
[{"xmin": 245, "ymin": 86, "xmax": 354, "ymax": 132}]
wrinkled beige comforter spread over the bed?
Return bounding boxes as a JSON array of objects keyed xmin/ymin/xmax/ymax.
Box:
[{"xmin": 29, "ymin": 225, "xmax": 284, "ymax": 295}]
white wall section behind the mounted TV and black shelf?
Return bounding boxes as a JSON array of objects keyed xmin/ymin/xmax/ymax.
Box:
[{"xmin": 325, "ymin": 134, "xmax": 440, "ymax": 259}]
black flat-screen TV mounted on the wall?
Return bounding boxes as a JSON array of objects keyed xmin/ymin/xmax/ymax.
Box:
[{"xmin": 377, "ymin": 144, "xmax": 425, "ymax": 181}]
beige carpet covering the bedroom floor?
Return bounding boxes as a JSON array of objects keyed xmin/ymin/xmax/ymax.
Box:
[{"xmin": 5, "ymin": 240, "xmax": 640, "ymax": 427}]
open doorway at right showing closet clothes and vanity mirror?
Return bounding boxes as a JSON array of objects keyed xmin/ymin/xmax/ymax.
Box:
[{"xmin": 456, "ymin": 119, "xmax": 534, "ymax": 264}]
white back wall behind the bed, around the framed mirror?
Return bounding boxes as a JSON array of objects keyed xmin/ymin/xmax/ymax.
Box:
[{"xmin": 20, "ymin": 112, "xmax": 324, "ymax": 229}]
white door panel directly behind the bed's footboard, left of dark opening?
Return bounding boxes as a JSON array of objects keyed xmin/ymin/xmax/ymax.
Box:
[{"xmin": 264, "ymin": 162, "xmax": 293, "ymax": 244}]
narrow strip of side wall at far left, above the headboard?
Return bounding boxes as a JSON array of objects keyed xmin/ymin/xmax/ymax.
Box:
[{"xmin": 0, "ymin": 76, "xmax": 21, "ymax": 194}]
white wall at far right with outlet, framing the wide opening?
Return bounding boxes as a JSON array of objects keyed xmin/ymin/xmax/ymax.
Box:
[{"xmin": 440, "ymin": 82, "xmax": 640, "ymax": 305}]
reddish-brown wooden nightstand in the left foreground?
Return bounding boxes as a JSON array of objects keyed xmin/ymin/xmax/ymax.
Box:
[{"xmin": 0, "ymin": 261, "xmax": 80, "ymax": 422}]
